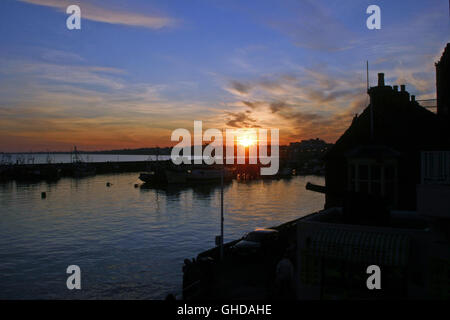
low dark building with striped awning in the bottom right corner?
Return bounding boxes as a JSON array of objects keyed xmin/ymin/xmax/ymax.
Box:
[{"xmin": 297, "ymin": 151, "xmax": 450, "ymax": 299}]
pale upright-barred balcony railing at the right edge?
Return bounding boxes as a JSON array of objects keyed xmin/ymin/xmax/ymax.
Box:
[{"xmin": 421, "ymin": 151, "xmax": 450, "ymax": 184}]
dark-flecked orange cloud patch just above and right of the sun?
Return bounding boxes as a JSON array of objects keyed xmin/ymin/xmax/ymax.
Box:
[{"xmin": 224, "ymin": 67, "xmax": 367, "ymax": 143}]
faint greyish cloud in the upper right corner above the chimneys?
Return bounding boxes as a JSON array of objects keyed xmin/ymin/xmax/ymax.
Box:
[{"xmin": 363, "ymin": 0, "xmax": 450, "ymax": 99}]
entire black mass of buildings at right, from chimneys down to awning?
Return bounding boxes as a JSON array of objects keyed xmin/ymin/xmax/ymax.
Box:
[{"xmin": 297, "ymin": 45, "xmax": 450, "ymax": 299}]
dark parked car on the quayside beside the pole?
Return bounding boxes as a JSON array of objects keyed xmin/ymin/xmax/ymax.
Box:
[{"xmin": 232, "ymin": 229, "xmax": 278, "ymax": 256}]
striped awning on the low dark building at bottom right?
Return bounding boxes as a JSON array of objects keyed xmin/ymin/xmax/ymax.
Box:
[{"xmin": 309, "ymin": 228, "xmax": 410, "ymax": 266}]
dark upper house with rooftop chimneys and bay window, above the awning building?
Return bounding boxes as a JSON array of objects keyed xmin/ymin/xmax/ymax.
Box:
[{"xmin": 325, "ymin": 45, "xmax": 450, "ymax": 210}]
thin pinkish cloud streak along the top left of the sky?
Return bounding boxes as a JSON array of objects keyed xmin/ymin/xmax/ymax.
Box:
[{"xmin": 19, "ymin": 0, "xmax": 175, "ymax": 29}]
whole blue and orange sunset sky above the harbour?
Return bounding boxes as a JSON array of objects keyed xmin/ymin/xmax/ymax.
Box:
[{"xmin": 0, "ymin": 0, "xmax": 450, "ymax": 152}]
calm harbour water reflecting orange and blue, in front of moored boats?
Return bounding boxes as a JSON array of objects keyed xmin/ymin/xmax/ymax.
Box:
[{"xmin": 0, "ymin": 173, "xmax": 324, "ymax": 299}]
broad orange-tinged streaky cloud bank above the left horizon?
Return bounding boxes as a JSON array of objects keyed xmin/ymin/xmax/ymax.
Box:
[{"xmin": 0, "ymin": 52, "xmax": 218, "ymax": 151}]
